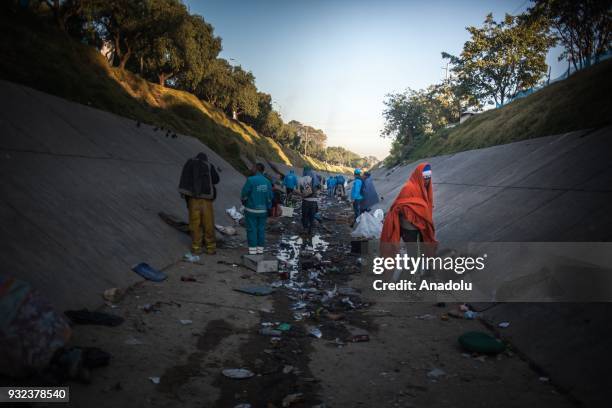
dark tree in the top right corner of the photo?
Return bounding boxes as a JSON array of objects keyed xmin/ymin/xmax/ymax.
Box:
[{"xmin": 528, "ymin": 0, "xmax": 612, "ymax": 69}]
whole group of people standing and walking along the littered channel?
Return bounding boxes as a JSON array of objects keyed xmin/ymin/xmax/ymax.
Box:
[{"xmin": 179, "ymin": 153, "xmax": 436, "ymax": 255}]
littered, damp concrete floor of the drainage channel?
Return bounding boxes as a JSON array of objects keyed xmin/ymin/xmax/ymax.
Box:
[{"xmin": 64, "ymin": 196, "xmax": 573, "ymax": 407}]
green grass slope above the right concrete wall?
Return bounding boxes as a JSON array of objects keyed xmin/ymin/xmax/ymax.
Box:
[{"xmin": 405, "ymin": 60, "xmax": 612, "ymax": 161}]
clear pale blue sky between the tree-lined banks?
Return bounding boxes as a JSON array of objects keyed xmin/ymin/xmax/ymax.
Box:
[{"xmin": 186, "ymin": 0, "xmax": 567, "ymax": 159}]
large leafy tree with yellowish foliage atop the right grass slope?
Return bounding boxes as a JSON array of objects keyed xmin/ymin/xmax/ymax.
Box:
[{"xmin": 442, "ymin": 14, "xmax": 555, "ymax": 105}]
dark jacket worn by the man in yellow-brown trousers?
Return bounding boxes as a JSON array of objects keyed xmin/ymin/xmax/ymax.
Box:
[{"xmin": 179, "ymin": 153, "xmax": 219, "ymax": 200}]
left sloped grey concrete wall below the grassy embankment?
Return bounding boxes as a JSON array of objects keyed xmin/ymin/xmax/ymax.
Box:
[{"xmin": 0, "ymin": 81, "xmax": 244, "ymax": 309}]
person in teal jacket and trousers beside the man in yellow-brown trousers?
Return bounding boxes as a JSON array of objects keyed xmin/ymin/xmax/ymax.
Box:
[{"xmin": 240, "ymin": 163, "xmax": 272, "ymax": 255}]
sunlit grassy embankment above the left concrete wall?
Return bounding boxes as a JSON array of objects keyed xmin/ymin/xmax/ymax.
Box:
[{"xmin": 0, "ymin": 11, "xmax": 350, "ymax": 172}]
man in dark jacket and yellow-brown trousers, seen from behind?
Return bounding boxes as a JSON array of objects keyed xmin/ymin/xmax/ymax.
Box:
[{"xmin": 179, "ymin": 153, "xmax": 219, "ymax": 255}]
